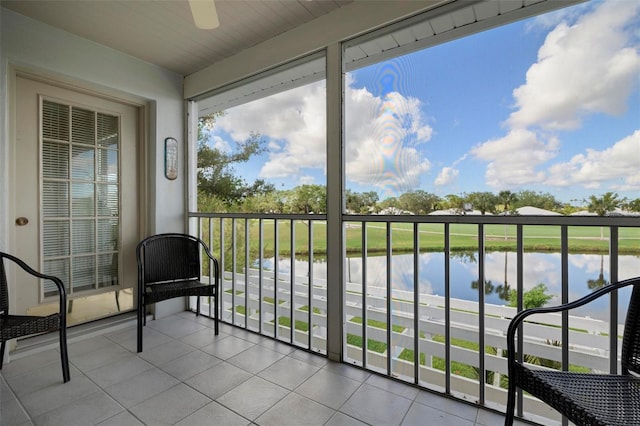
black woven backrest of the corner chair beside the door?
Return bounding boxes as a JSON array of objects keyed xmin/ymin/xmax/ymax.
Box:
[{"xmin": 138, "ymin": 234, "xmax": 201, "ymax": 284}]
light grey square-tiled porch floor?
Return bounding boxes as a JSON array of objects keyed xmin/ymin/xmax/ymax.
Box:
[{"xmin": 0, "ymin": 312, "xmax": 524, "ymax": 426}]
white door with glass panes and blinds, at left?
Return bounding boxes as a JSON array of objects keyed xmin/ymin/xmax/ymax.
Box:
[{"xmin": 10, "ymin": 76, "xmax": 141, "ymax": 324}]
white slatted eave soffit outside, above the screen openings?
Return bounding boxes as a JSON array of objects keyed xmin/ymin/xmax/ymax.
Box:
[{"xmin": 198, "ymin": 0, "xmax": 581, "ymax": 116}]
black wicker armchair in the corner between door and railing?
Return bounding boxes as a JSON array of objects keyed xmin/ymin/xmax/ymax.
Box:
[{"xmin": 136, "ymin": 233, "xmax": 220, "ymax": 352}]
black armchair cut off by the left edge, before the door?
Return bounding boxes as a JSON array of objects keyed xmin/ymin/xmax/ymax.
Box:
[{"xmin": 0, "ymin": 252, "xmax": 71, "ymax": 383}]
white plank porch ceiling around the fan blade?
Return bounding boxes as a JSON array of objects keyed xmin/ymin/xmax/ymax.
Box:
[{"xmin": 0, "ymin": 0, "xmax": 353, "ymax": 75}]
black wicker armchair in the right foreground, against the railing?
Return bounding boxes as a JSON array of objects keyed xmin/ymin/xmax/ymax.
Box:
[{"xmin": 505, "ymin": 277, "xmax": 640, "ymax": 426}]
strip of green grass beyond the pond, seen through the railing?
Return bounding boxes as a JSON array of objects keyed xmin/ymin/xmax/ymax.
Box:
[{"xmin": 204, "ymin": 220, "xmax": 640, "ymax": 257}]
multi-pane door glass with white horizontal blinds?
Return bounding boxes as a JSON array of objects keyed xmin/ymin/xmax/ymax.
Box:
[{"xmin": 40, "ymin": 100, "xmax": 120, "ymax": 297}]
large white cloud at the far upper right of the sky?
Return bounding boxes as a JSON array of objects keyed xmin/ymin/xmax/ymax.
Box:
[{"xmin": 470, "ymin": 1, "xmax": 640, "ymax": 191}]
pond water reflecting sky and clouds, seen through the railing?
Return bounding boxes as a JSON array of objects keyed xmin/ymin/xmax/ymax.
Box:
[{"xmin": 256, "ymin": 252, "xmax": 640, "ymax": 323}]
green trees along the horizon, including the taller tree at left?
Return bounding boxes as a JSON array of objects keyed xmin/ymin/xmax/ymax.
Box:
[{"xmin": 197, "ymin": 112, "xmax": 640, "ymax": 216}]
